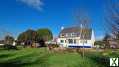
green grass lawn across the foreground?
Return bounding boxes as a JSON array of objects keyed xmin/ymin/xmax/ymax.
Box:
[{"xmin": 0, "ymin": 48, "xmax": 119, "ymax": 67}]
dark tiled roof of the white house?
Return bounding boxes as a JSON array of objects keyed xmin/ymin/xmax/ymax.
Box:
[{"xmin": 59, "ymin": 27, "xmax": 92, "ymax": 39}]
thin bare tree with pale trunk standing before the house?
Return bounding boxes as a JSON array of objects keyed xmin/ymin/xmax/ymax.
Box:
[{"xmin": 75, "ymin": 10, "xmax": 91, "ymax": 57}]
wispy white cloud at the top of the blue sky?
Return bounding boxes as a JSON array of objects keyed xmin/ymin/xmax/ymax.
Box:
[{"xmin": 16, "ymin": 0, "xmax": 43, "ymax": 10}]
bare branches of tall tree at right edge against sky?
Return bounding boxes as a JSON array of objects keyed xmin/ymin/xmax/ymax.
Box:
[{"xmin": 105, "ymin": 0, "xmax": 119, "ymax": 39}]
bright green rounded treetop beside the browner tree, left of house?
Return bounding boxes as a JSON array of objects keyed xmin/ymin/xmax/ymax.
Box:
[{"xmin": 37, "ymin": 28, "xmax": 53, "ymax": 41}]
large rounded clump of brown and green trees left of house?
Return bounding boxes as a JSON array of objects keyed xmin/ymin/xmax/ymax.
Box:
[{"xmin": 17, "ymin": 29, "xmax": 53, "ymax": 47}]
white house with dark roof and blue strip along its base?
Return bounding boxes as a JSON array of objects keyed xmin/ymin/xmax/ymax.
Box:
[{"xmin": 57, "ymin": 27, "xmax": 95, "ymax": 48}]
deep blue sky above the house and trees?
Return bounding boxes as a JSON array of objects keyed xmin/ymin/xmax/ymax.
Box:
[{"xmin": 0, "ymin": 0, "xmax": 105, "ymax": 39}]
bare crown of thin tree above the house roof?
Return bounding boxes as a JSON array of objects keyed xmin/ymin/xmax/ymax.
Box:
[{"xmin": 74, "ymin": 9, "xmax": 91, "ymax": 28}]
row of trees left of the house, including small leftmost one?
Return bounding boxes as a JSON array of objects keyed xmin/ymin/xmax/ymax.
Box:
[{"xmin": 0, "ymin": 28, "xmax": 53, "ymax": 47}]
